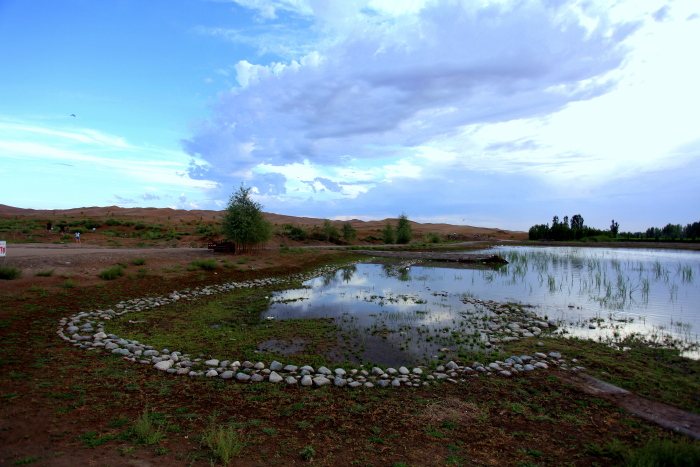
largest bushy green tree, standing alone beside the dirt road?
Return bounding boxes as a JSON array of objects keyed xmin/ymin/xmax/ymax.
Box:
[{"xmin": 221, "ymin": 184, "xmax": 272, "ymax": 251}]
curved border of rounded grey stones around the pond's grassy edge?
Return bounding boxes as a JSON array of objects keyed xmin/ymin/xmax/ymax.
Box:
[{"xmin": 56, "ymin": 263, "xmax": 584, "ymax": 388}]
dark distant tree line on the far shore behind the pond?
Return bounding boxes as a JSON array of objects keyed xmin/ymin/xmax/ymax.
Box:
[{"xmin": 529, "ymin": 214, "xmax": 700, "ymax": 241}]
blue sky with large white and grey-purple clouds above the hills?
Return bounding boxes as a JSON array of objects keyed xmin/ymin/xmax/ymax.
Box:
[{"xmin": 0, "ymin": 0, "xmax": 700, "ymax": 232}]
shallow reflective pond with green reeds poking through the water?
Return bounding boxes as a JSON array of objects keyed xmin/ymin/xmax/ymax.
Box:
[{"xmin": 264, "ymin": 247, "xmax": 700, "ymax": 365}]
